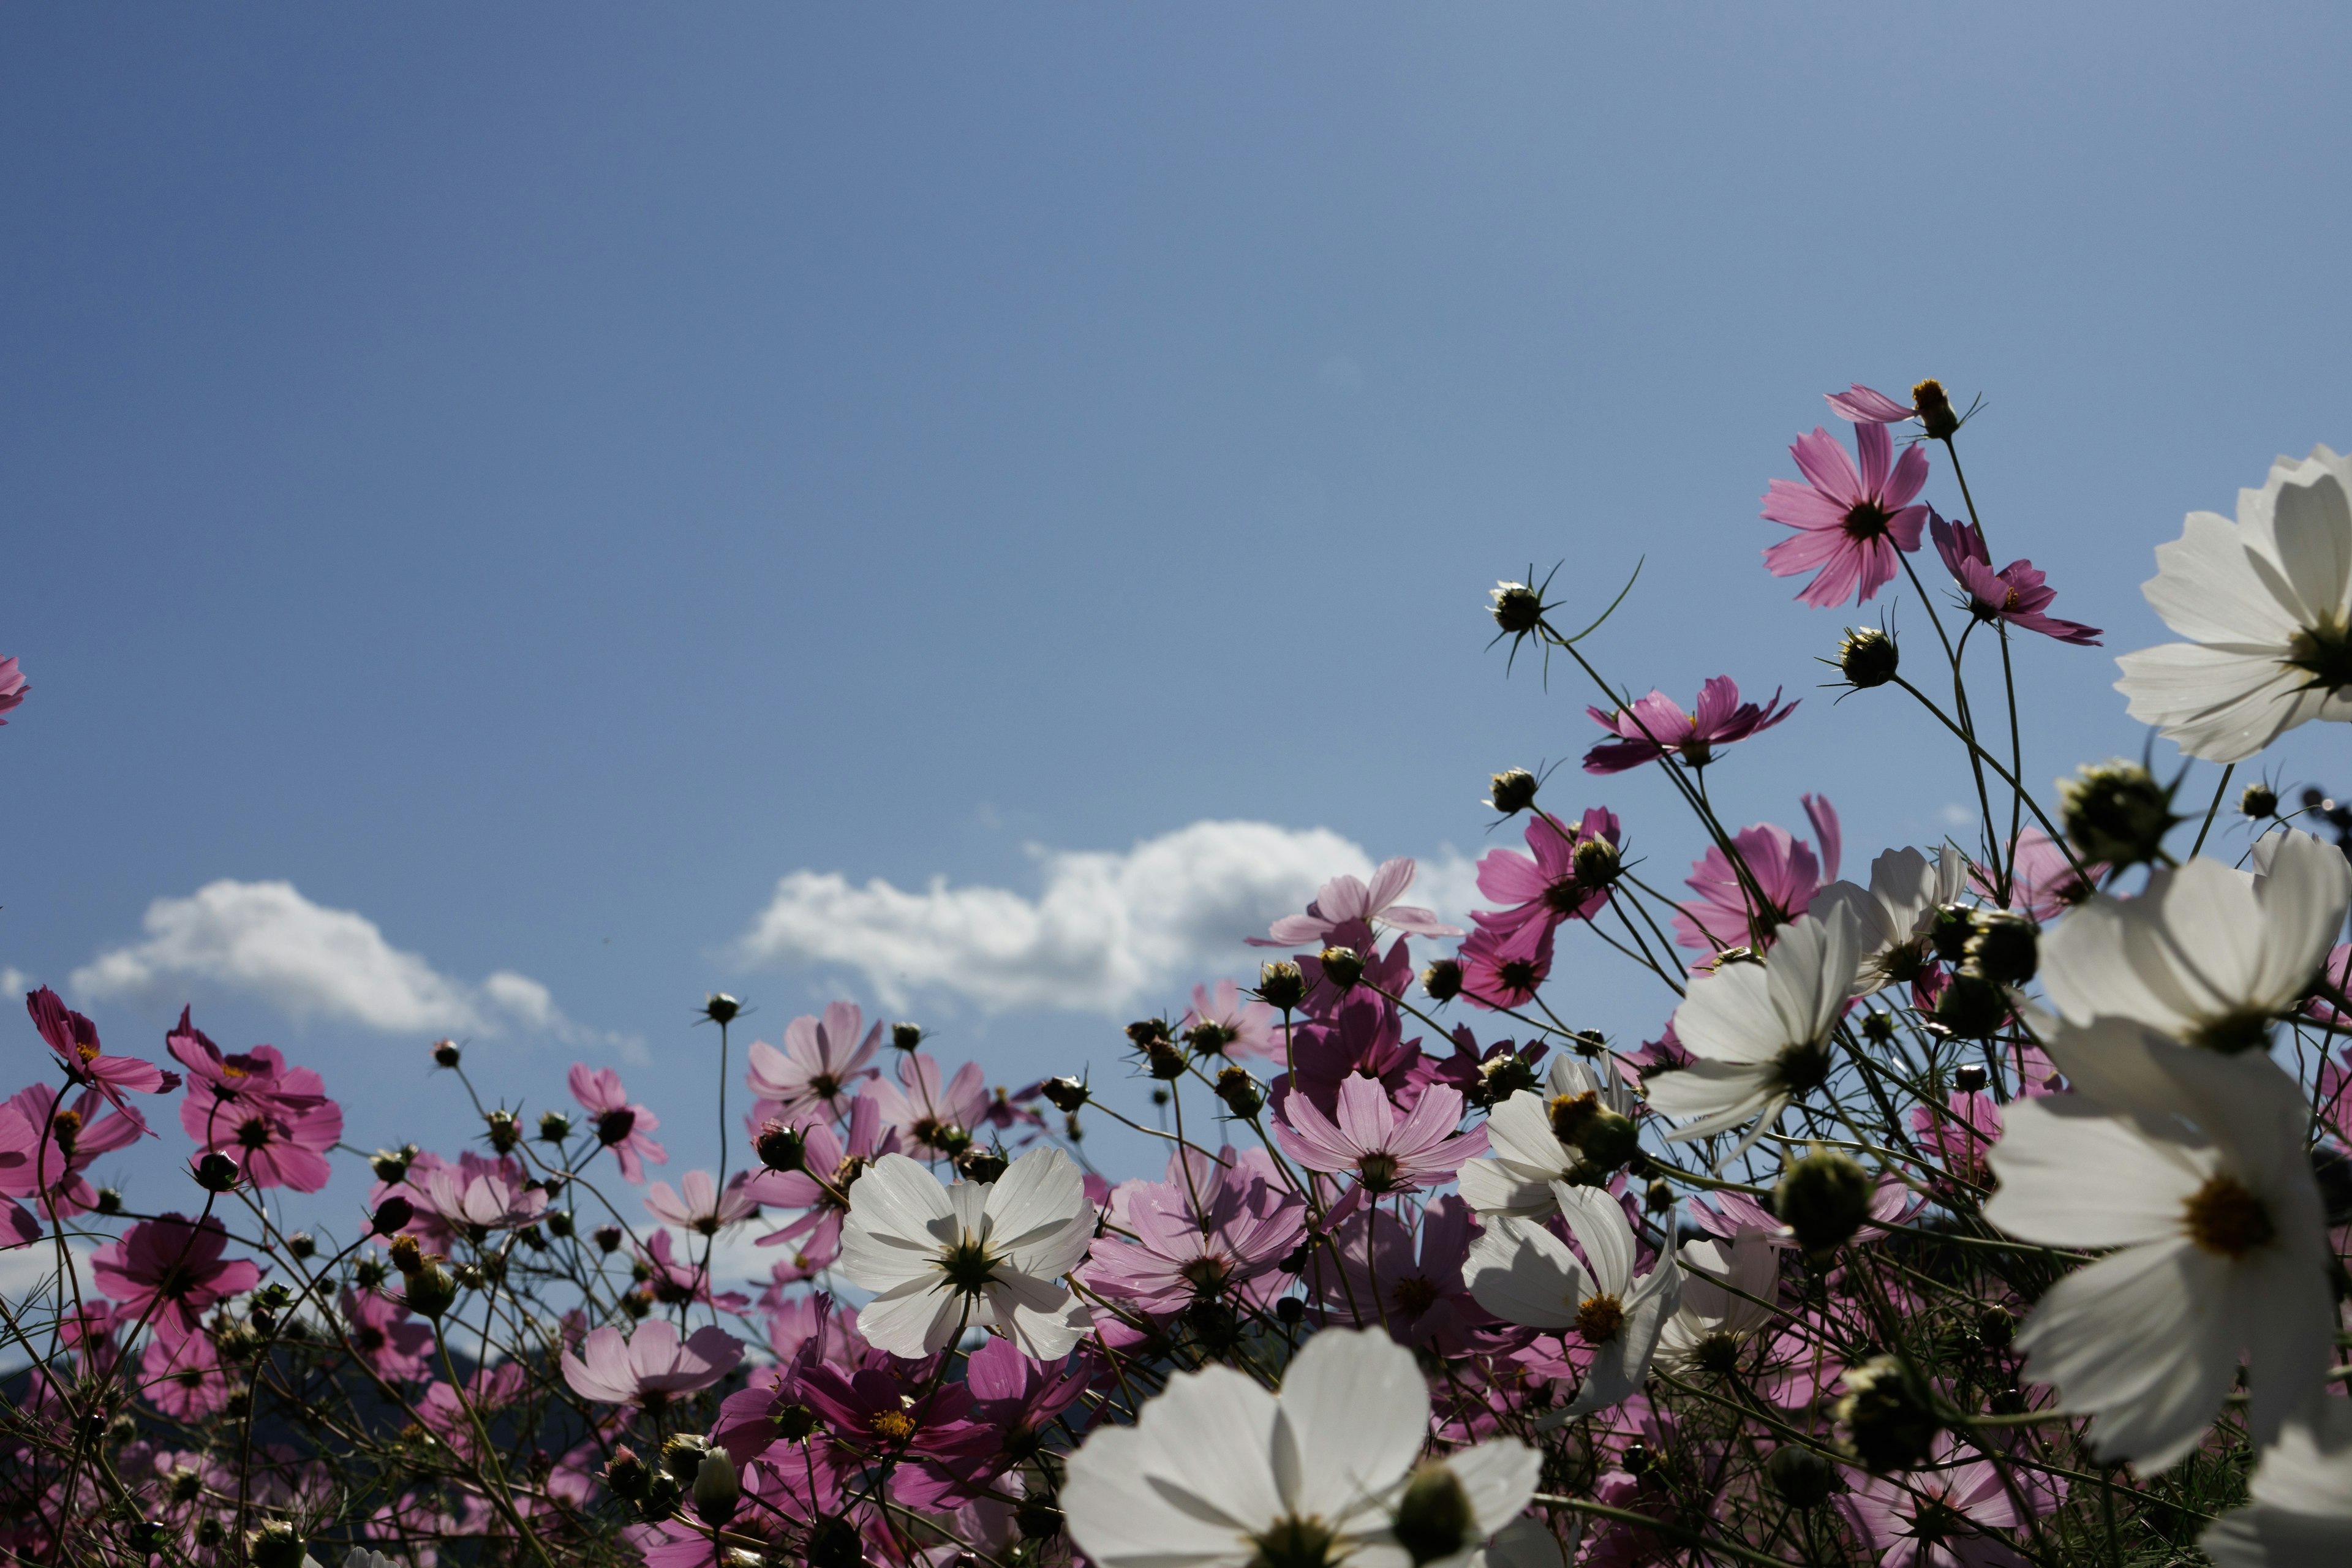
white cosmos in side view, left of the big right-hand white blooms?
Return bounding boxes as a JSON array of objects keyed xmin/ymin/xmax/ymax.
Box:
[{"xmin": 1642, "ymin": 905, "xmax": 1863, "ymax": 1150}]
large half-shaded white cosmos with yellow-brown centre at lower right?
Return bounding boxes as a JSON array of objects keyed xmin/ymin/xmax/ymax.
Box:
[{"xmin": 1985, "ymin": 1018, "xmax": 2335, "ymax": 1472}]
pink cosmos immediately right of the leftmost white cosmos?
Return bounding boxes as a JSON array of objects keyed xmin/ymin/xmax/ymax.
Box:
[{"xmin": 1080, "ymin": 1145, "xmax": 1305, "ymax": 1316}]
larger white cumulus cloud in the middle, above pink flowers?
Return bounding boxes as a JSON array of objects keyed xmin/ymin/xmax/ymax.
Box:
[{"xmin": 736, "ymin": 823, "xmax": 1468, "ymax": 1013}]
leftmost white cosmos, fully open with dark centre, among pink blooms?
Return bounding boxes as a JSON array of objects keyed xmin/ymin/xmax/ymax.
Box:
[{"xmin": 842, "ymin": 1150, "xmax": 1094, "ymax": 1361}]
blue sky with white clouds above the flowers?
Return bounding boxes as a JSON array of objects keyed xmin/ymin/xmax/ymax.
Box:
[{"xmin": 0, "ymin": 5, "xmax": 2352, "ymax": 1222}]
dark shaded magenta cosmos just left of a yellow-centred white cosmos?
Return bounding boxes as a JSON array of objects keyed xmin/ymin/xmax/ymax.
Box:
[{"xmin": 1308, "ymin": 1192, "xmax": 1496, "ymax": 1357}]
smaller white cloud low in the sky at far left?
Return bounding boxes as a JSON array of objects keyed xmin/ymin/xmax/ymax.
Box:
[{"xmin": 73, "ymin": 879, "xmax": 625, "ymax": 1049}]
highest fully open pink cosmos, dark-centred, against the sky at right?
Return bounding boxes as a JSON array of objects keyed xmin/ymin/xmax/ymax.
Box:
[{"xmin": 1764, "ymin": 423, "xmax": 1926, "ymax": 606}]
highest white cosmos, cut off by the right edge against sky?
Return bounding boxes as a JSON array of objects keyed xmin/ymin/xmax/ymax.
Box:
[{"xmin": 2114, "ymin": 447, "xmax": 2352, "ymax": 762}]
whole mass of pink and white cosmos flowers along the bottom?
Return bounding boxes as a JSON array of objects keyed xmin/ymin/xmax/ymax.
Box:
[{"xmin": 0, "ymin": 381, "xmax": 2352, "ymax": 1568}]
